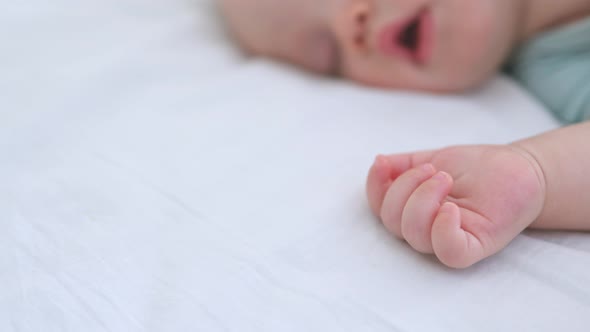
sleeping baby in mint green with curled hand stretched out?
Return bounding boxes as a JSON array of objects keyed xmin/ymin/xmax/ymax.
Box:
[{"xmin": 220, "ymin": 0, "xmax": 590, "ymax": 268}]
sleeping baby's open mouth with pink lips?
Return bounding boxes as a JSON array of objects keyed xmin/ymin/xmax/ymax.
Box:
[{"xmin": 379, "ymin": 10, "xmax": 434, "ymax": 64}]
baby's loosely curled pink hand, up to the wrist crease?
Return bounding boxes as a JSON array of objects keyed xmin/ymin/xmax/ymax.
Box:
[{"xmin": 367, "ymin": 145, "xmax": 545, "ymax": 268}]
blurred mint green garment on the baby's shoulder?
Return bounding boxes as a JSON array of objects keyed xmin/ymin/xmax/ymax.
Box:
[{"xmin": 508, "ymin": 18, "xmax": 590, "ymax": 123}]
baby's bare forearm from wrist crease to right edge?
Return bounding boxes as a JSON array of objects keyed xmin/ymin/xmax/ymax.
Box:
[{"xmin": 512, "ymin": 122, "xmax": 590, "ymax": 230}]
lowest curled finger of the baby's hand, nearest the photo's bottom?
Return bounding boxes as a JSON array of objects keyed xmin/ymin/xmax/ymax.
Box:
[{"xmin": 432, "ymin": 202, "xmax": 488, "ymax": 269}]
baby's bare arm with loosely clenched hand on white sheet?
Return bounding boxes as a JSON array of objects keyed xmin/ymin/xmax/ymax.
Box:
[{"xmin": 367, "ymin": 122, "xmax": 590, "ymax": 268}]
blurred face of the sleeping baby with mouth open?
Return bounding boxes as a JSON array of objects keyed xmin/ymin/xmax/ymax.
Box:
[{"xmin": 221, "ymin": 0, "xmax": 526, "ymax": 92}]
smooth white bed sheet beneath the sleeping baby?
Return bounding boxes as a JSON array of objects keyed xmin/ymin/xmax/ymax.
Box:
[{"xmin": 0, "ymin": 0, "xmax": 590, "ymax": 332}]
